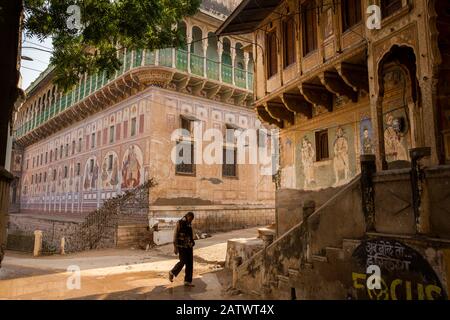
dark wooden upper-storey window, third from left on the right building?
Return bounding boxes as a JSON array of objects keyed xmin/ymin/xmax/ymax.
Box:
[{"xmin": 301, "ymin": 0, "xmax": 317, "ymax": 56}]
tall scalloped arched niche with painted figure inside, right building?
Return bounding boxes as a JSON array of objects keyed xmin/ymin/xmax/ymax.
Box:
[{"xmin": 378, "ymin": 45, "xmax": 423, "ymax": 169}]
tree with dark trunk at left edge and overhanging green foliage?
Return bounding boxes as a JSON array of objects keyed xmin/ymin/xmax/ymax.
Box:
[{"xmin": 0, "ymin": 0, "xmax": 200, "ymax": 265}]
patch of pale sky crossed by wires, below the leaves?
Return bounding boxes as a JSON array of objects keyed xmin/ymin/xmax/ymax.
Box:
[{"xmin": 20, "ymin": 35, "xmax": 53, "ymax": 90}]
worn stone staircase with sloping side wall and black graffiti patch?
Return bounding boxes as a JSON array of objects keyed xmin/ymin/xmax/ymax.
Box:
[{"xmin": 233, "ymin": 164, "xmax": 450, "ymax": 300}]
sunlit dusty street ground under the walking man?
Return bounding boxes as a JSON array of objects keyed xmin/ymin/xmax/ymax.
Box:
[{"xmin": 0, "ymin": 228, "xmax": 257, "ymax": 300}]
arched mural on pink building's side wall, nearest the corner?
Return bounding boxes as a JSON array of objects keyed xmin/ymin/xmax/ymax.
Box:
[{"xmin": 122, "ymin": 145, "xmax": 144, "ymax": 189}]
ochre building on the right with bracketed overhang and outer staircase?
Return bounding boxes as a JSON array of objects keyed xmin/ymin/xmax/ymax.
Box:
[{"xmin": 217, "ymin": 0, "xmax": 450, "ymax": 299}]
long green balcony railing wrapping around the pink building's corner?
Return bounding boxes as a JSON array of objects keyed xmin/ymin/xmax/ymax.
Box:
[{"xmin": 15, "ymin": 48, "xmax": 253, "ymax": 138}]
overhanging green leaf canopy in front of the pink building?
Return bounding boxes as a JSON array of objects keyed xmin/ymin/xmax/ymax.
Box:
[{"xmin": 23, "ymin": 0, "xmax": 201, "ymax": 90}]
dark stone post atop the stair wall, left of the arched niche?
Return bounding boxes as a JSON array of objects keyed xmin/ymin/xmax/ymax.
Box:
[{"xmin": 360, "ymin": 154, "xmax": 377, "ymax": 231}]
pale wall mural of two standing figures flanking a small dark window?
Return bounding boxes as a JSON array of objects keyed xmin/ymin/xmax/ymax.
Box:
[{"xmin": 295, "ymin": 125, "xmax": 356, "ymax": 190}]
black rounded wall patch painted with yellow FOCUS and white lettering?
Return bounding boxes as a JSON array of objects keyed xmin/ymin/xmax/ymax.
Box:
[{"xmin": 351, "ymin": 238, "xmax": 447, "ymax": 300}]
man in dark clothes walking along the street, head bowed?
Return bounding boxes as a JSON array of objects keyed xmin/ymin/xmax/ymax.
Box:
[{"xmin": 169, "ymin": 212, "xmax": 195, "ymax": 287}]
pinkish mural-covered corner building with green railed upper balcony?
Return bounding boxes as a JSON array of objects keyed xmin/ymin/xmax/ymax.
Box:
[{"xmin": 13, "ymin": 1, "xmax": 274, "ymax": 242}]
